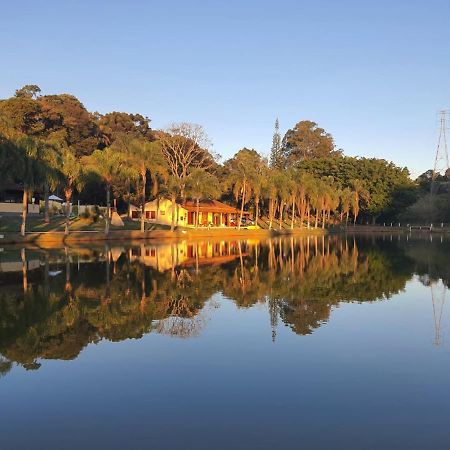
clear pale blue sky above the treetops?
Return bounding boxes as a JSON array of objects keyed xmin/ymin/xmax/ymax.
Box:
[{"xmin": 0, "ymin": 0, "xmax": 450, "ymax": 175}]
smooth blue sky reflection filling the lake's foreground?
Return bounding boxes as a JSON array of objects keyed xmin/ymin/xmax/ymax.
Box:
[{"xmin": 0, "ymin": 278, "xmax": 450, "ymax": 449}]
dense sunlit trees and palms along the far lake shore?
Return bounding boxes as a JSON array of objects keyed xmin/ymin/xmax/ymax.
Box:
[{"xmin": 0, "ymin": 85, "xmax": 450, "ymax": 233}]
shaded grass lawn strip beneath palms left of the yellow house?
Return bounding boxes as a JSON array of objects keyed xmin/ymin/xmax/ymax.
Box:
[{"xmin": 0, "ymin": 214, "xmax": 165, "ymax": 233}]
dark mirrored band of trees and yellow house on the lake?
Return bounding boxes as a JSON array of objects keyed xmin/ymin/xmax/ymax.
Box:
[{"xmin": 0, "ymin": 236, "xmax": 450, "ymax": 370}]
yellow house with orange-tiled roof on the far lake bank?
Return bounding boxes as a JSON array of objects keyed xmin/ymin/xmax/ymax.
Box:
[{"xmin": 131, "ymin": 199, "xmax": 250, "ymax": 227}]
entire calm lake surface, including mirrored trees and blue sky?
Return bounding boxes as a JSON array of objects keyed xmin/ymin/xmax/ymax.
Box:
[{"xmin": 0, "ymin": 236, "xmax": 450, "ymax": 450}]
